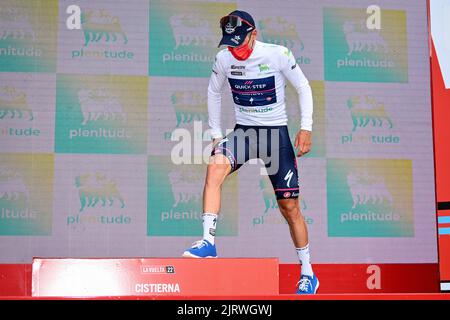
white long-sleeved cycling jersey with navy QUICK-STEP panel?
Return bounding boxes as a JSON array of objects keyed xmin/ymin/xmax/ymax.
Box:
[{"xmin": 208, "ymin": 41, "xmax": 313, "ymax": 138}]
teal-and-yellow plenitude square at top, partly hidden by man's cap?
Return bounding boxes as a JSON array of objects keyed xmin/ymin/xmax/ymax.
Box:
[{"xmin": 149, "ymin": 0, "xmax": 236, "ymax": 77}]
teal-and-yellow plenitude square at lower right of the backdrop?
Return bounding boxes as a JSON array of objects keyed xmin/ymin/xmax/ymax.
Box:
[{"xmin": 327, "ymin": 159, "xmax": 414, "ymax": 237}]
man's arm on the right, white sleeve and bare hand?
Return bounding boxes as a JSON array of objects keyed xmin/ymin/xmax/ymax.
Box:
[{"xmin": 281, "ymin": 51, "xmax": 313, "ymax": 156}]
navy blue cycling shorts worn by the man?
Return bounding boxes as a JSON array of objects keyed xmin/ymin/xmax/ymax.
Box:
[{"xmin": 211, "ymin": 124, "xmax": 299, "ymax": 199}]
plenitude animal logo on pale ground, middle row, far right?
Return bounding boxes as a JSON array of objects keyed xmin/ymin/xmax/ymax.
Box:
[{"xmin": 341, "ymin": 95, "xmax": 400, "ymax": 144}]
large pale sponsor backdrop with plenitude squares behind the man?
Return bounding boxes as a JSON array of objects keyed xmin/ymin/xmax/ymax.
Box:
[{"xmin": 0, "ymin": 0, "xmax": 437, "ymax": 263}]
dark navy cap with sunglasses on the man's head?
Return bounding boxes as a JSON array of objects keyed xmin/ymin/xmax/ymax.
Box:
[{"xmin": 219, "ymin": 10, "xmax": 255, "ymax": 47}]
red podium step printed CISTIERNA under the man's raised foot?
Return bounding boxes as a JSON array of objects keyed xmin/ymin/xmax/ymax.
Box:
[{"xmin": 32, "ymin": 258, "xmax": 279, "ymax": 297}]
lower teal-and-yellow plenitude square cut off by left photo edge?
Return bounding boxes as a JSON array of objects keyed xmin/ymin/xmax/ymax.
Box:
[{"xmin": 0, "ymin": 154, "xmax": 53, "ymax": 236}]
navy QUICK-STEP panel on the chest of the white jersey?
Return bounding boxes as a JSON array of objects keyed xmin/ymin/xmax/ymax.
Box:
[{"xmin": 228, "ymin": 76, "xmax": 277, "ymax": 107}]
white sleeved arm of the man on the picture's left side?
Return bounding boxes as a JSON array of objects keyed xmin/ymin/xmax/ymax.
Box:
[{"xmin": 208, "ymin": 57, "xmax": 226, "ymax": 140}]
